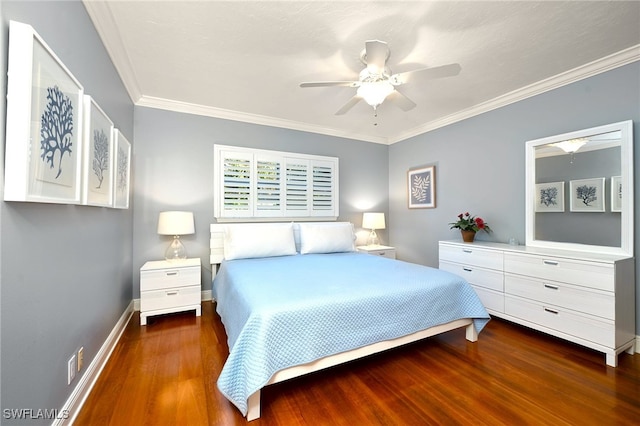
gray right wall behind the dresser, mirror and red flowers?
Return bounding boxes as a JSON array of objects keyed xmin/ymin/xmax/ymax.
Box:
[{"xmin": 389, "ymin": 62, "xmax": 640, "ymax": 334}]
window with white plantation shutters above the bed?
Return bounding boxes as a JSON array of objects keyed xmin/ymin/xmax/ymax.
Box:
[{"xmin": 213, "ymin": 145, "xmax": 338, "ymax": 221}]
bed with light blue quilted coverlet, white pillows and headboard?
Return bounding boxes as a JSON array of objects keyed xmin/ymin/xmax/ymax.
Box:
[{"xmin": 211, "ymin": 222, "xmax": 490, "ymax": 420}]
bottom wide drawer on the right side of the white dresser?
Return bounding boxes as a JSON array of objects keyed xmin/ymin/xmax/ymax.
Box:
[{"xmin": 504, "ymin": 295, "xmax": 615, "ymax": 348}]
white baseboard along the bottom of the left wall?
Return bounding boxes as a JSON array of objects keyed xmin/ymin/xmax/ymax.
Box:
[{"xmin": 57, "ymin": 301, "xmax": 134, "ymax": 425}]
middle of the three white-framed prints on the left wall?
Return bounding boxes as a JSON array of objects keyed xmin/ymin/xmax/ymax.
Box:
[{"xmin": 82, "ymin": 95, "xmax": 113, "ymax": 207}]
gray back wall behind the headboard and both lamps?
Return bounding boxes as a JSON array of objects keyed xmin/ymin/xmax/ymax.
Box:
[{"xmin": 133, "ymin": 107, "xmax": 388, "ymax": 298}]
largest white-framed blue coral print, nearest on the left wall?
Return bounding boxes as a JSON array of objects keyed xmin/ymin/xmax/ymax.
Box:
[{"xmin": 4, "ymin": 21, "xmax": 84, "ymax": 204}]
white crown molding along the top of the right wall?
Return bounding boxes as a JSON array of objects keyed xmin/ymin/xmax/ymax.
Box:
[{"xmin": 389, "ymin": 44, "xmax": 640, "ymax": 145}]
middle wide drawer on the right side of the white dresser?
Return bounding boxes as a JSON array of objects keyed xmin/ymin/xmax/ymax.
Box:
[{"xmin": 504, "ymin": 274, "xmax": 615, "ymax": 320}]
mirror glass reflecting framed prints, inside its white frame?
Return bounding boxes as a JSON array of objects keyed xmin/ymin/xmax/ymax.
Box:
[{"xmin": 535, "ymin": 131, "xmax": 622, "ymax": 247}]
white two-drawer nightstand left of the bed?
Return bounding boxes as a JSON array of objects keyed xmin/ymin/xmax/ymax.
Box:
[{"xmin": 140, "ymin": 258, "xmax": 201, "ymax": 325}]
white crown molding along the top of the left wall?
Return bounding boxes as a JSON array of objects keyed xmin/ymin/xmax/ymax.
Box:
[{"xmin": 82, "ymin": 0, "xmax": 142, "ymax": 103}]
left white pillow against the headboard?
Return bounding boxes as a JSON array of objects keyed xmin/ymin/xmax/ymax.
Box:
[{"xmin": 224, "ymin": 223, "xmax": 296, "ymax": 260}]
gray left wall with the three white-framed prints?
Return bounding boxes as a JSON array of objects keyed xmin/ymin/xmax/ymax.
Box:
[{"xmin": 0, "ymin": 0, "xmax": 134, "ymax": 425}]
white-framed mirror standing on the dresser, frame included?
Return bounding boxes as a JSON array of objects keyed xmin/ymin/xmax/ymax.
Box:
[{"xmin": 525, "ymin": 120, "xmax": 633, "ymax": 256}]
